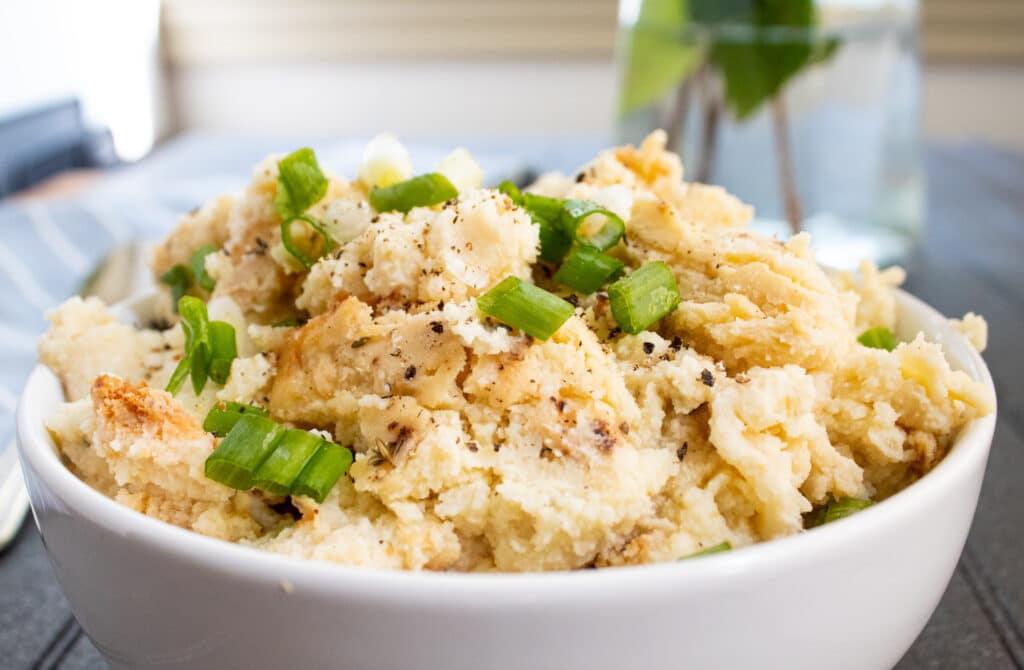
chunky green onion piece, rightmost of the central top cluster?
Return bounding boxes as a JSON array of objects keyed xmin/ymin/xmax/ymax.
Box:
[{"xmin": 608, "ymin": 260, "xmax": 682, "ymax": 335}]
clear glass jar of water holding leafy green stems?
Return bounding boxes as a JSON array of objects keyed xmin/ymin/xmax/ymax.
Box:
[{"xmin": 616, "ymin": 0, "xmax": 924, "ymax": 268}]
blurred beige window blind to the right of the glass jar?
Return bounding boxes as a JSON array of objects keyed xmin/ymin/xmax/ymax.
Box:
[{"xmin": 922, "ymin": 0, "xmax": 1024, "ymax": 62}]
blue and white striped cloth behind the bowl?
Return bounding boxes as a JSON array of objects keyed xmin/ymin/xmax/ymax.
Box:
[{"xmin": 0, "ymin": 133, "xmax": 569, "ymax": 451}]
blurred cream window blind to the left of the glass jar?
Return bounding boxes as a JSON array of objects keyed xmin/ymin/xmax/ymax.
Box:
[{"xmin": 164, "ymin": 0, "xmax": 616, "ymax": 66}]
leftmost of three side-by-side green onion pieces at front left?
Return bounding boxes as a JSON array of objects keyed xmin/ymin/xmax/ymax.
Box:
[{"xmin": 204, "ymin": 414, "xmax": 285, "ymax": 491}]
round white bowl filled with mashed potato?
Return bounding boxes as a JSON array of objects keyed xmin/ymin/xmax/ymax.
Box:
[{"xmin": 17, "ymin": 294, "xmax": 995, "ymax": 670}]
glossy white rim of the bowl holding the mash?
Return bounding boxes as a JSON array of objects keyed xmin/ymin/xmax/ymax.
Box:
[{"xmin": 16, "ymin": 290, "xmax": 996, "ymax": 602}]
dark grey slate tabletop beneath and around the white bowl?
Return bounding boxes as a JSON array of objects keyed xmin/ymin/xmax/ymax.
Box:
[{"xmin": 0, "ymin": 137, "xmax": 1024, "ymax": 670}]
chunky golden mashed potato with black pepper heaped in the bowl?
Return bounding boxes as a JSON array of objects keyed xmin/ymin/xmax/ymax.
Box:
[{"xmin": 40, "ymin": 132, "xmax": 994, "ymax": 571}]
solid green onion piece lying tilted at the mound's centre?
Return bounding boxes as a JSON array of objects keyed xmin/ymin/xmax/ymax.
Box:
[{"xmin": 476, "ymin": 277, "xmax": 574, "ymax": 340}]
